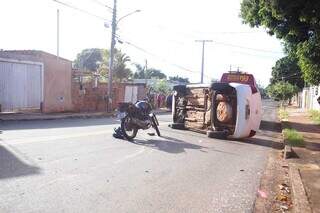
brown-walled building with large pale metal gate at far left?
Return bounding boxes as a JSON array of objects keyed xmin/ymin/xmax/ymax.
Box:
[{"xmin": 0, "ymin": 50, "xmax": 73, "ymax": 113}]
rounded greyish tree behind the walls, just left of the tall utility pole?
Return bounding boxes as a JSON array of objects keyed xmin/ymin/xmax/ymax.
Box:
[{"xmin": 74, "ymin": 48, "xmax": 103, "ymax": 72}]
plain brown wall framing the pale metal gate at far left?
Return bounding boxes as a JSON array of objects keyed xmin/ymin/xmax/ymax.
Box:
[{"xmin": 0, "ymin": 51, "xmax": 72, "ymax": 112}]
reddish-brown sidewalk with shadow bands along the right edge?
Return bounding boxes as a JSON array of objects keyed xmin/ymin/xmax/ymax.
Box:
[{"xmin": 287, "ymin": 107, "xmax": 320, "ymax": 213}]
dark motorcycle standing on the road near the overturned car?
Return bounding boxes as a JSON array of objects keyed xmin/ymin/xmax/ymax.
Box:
[{"xmin": 115, "ymin": 101, "xmax": 160, "ymax": 140}]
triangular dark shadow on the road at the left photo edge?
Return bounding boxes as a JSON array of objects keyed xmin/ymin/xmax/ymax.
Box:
[{"xmin": 0, "ymin": 145, "xmax": 40, "ymax": 179}]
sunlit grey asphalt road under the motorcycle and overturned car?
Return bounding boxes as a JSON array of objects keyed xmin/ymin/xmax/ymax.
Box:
[{"xmin": 0, "ymin": 102, "xmax": 275, "ymax": 213}]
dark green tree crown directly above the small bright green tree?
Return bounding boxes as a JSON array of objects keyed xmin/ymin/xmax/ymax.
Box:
[{"xmin": 270, "ymin": 56, "xmax": 304, "ymax": 89}]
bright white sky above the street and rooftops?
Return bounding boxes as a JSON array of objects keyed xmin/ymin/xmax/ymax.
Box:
[{"xmin": 0, "ymin": 0, "xmax": 283, "ymax": 85}]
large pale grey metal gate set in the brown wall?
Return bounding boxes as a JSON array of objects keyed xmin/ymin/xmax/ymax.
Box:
[{"xmin": 0, "ymin": 59, "xmax": 43, "ymax": 112}]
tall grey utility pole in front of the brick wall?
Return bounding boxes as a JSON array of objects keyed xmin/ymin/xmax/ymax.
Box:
[{"xmin": 107, "ymin": 0, "xmax": 117, "ymax": 112}]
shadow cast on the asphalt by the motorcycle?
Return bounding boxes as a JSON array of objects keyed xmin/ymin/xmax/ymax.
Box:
[{"xmin": 133, "ymin": 136, "xmax": 207, "ymax": 154}]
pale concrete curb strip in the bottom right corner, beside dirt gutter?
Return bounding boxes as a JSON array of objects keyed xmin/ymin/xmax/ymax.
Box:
[{"xmin": 289, "ymin": 163, "xmax": 312, "ymax": 213}]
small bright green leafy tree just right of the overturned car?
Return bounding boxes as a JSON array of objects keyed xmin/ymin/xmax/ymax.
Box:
[{"xmin": 267, "ymin": 81, "xmax": 299, "ymax": 102}]
